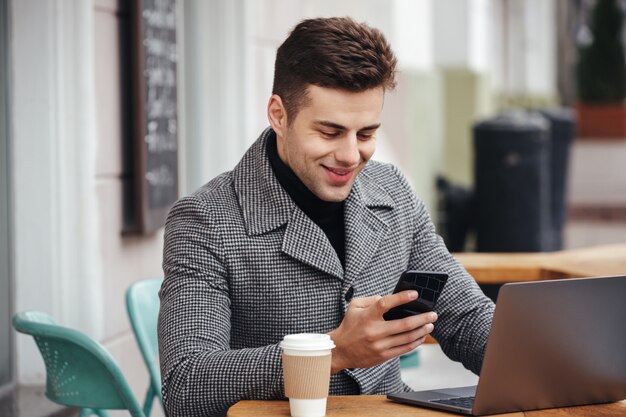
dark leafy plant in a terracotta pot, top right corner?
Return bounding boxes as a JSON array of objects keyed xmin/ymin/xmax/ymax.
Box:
[{"xmin": 576, "ymin": 0, "xmax": 626, "ymax": 139}]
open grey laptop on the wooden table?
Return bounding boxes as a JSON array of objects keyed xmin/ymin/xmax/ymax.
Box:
[{"xmin": 387, "ymin": 276, "xmax": 626, "ymax": 416}]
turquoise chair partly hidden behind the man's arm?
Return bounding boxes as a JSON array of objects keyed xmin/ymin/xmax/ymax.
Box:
[{"xmin": 126, "ymin": 279, "xmax": 163, "ymax": 416}]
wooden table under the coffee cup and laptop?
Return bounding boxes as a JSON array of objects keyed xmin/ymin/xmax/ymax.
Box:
[{"xmin": 228, "ymin": 395, "xmax": 626, "ymax": 417}]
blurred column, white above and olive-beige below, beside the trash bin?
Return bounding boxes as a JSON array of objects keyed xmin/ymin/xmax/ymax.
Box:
[{"xmin": 433, "ymin": 0, "xmax": 492, "ymax": 185}]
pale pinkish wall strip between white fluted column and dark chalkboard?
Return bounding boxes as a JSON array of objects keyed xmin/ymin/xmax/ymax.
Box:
[{"xmin": 93, "ymin": 0, "xmax": 163, "ymax": 415}]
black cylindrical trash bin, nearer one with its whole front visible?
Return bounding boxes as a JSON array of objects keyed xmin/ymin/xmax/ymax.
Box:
[{"xmin": 473, "ymin": 110, "xmax": 554, "ymax": 252}]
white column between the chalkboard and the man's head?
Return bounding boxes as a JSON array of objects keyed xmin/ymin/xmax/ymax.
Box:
[{"xmin": 182, "ymin": 0, "xmax": 250, "ymax": 193}]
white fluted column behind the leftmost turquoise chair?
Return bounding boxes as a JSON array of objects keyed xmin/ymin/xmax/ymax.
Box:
[{"xmin": 11, "ymin": 0, "xmax": 102, "ymax": 384}]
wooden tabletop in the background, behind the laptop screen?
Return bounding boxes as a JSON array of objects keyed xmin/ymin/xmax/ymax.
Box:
[{"xmin": 454, "ymin": 242, "xmax": 626, "ymax": 284}]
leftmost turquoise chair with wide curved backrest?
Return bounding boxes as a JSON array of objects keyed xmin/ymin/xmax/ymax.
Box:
[{"xmin": 13, "ymin": 311, "xmax": 145, "ymax": 417}]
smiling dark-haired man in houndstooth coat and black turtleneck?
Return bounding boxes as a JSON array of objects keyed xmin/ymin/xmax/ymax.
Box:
[{"xmin": 159, "ymin": 18, "xmax": 493, "ymax": 416}]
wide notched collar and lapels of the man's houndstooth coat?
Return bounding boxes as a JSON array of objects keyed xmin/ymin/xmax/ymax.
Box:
[{"xmin": 233, "ymin": 128, "xmax": 395, "ymax": 280}]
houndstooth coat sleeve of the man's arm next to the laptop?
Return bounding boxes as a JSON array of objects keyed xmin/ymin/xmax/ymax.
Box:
[{"xmin": 397, "ymin": 166, "xmax": 495, "ymax": 375}]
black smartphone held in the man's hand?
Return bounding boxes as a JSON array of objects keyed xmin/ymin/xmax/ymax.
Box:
[{"xmin": 383, "ymin": 271, "xmax": 448, "ymax": 320}]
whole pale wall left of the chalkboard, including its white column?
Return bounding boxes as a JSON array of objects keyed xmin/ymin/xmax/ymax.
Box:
[{"xmin": 11, "ymin": 0, "xmax": 163, "ymax": 415}]
